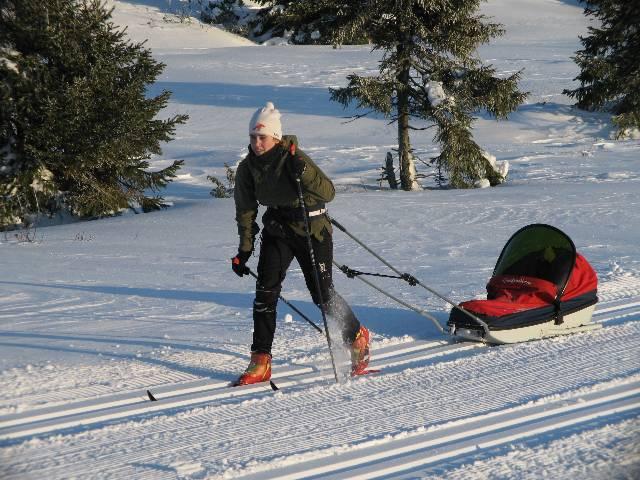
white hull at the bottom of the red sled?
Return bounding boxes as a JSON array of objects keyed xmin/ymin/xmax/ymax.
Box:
[{"xmin": 453, "ymin": 305, "xmax": 602, "ymax": 345}]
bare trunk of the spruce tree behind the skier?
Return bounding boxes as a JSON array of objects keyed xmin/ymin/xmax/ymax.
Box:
[{"xmin": 398, "ymin": 45, "xmax": 420, "ymax": 191}]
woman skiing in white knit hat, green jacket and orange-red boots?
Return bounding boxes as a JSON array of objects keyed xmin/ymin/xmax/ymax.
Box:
[{"xmin": 231, "ymin": 102, "xmax": 369, "ymax": 385}]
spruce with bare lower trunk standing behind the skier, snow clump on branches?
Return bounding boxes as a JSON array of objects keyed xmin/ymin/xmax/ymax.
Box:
[{"xmin": 295, "ymin": 0, "xmax": 526, "ymax": 190}]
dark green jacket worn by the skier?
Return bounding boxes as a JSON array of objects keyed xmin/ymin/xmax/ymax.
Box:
[{"xmin": 234, "ymin": 135, "xmax": 335, "ymax": 252}]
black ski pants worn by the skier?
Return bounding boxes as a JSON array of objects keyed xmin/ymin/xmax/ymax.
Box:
[{"xmin": 251, "ymin": 230, "xmax": 360, "ymax": 353}]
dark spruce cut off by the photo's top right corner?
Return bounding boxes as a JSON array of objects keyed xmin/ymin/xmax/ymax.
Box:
[{"xmin": 564, "ymin": 0, "xmax": 640, "ymax": 138}]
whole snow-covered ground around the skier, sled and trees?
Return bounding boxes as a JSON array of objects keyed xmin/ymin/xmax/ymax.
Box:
[{"xmin": 0, "ymin": 0, "xmax": 640, "ymax": 479}]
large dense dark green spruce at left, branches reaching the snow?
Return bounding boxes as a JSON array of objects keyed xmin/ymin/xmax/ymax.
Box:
[{"xmin": 0, "ymin": 0, "xmax": 187, "ymax": 228}]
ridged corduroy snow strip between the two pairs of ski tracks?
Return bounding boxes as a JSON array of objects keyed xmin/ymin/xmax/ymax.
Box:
[{"xmin": 2, "ymin": 316, "xmax": 638, "ymax": 478}]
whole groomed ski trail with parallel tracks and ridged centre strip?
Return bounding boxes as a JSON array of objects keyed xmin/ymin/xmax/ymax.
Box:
[{"xmin": 0, "ymin": 286, "xmax": 640, "ymax": 479}]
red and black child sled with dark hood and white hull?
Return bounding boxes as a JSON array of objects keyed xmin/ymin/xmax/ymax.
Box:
[{"xmin": 447, "ymin": 224, "xmax": 601, "ymax": 344}]
